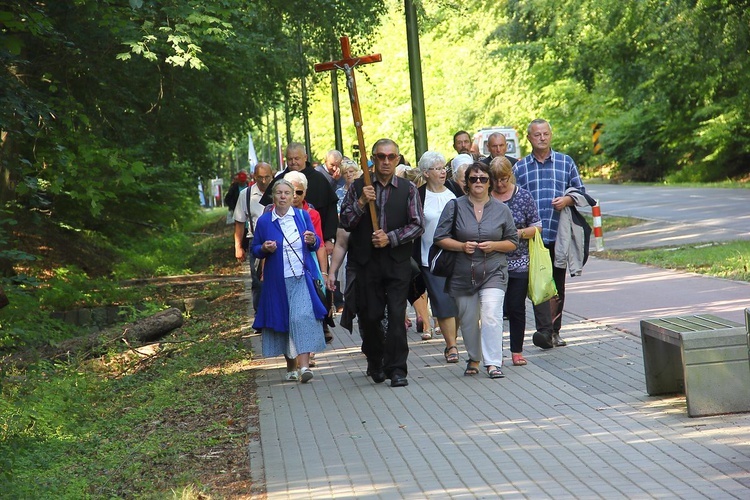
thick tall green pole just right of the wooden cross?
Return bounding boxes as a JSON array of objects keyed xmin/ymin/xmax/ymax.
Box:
[{"xmin": 404, "ymin": 0, "xmax": 427, "ymax": 160}]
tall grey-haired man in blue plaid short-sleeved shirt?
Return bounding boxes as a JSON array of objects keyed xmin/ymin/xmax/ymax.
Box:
[{"xmin": 514, "ymin": 119, "xmax": 585, "ymax": 349}]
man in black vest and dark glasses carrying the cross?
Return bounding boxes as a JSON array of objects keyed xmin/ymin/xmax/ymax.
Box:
[{"xmin": 340, "ymin": 139, "xmax": 424, "ymax": 387}]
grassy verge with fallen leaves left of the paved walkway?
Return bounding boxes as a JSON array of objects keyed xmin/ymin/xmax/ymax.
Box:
[{"xmin": 0, "ymin": 213, "xmax": 257, "ymax": 499}]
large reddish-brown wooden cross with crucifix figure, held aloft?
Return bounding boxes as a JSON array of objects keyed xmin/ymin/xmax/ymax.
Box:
[{"xmin": 315, "ymin": 36, "xmax": 382, "ymax": 231}]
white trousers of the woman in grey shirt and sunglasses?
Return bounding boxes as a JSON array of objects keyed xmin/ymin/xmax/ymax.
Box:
[{"xmin": 455, "ymin": 288, "xmax": 505, "ymax": 368}]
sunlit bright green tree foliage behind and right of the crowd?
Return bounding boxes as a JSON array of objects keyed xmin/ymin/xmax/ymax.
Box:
[{"xmin": 311, "ymin": 0, "xmax": 750, "ymax": 182}]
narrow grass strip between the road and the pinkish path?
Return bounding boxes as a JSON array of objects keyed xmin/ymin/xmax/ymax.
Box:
[{"xmin": 596, "ymin": 241, "xmax": 750, "ymax": 282}]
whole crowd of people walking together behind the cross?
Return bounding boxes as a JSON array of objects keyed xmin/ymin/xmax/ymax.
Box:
[{"xmin": 233, "ymin": 119, "xmax": 593, "ymax": 387}]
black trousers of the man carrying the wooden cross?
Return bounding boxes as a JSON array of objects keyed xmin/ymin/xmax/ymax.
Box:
[{"xmin": 355, "ymin": 254, "xmax": 411, "ymax": 378}]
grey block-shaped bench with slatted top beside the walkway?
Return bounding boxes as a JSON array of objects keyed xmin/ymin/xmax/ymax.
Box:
[{"xmin": 641, "ymin": 311, "xmax": 750, "ymax": 417}]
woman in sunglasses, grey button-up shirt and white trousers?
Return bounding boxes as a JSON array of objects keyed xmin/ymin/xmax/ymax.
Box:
[{"xmin": 434, "ymin": 162, "xmax": 518, "ymax": 378}]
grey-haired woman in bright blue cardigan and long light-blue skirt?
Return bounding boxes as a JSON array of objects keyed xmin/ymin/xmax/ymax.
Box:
[{"xmin": 253, "ymin": 179, "xmax": 327, "ymax": 382}]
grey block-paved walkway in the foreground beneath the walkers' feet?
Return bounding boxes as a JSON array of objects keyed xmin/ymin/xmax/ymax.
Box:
[{"xmin": 250, "ymin": 267, "xmax": 750, "ymax": 499}]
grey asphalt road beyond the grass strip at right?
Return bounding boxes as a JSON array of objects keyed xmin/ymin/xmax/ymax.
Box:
[{"xmin": 586, "ymin": 184, "xmax": 750, "ymax": 250}]
